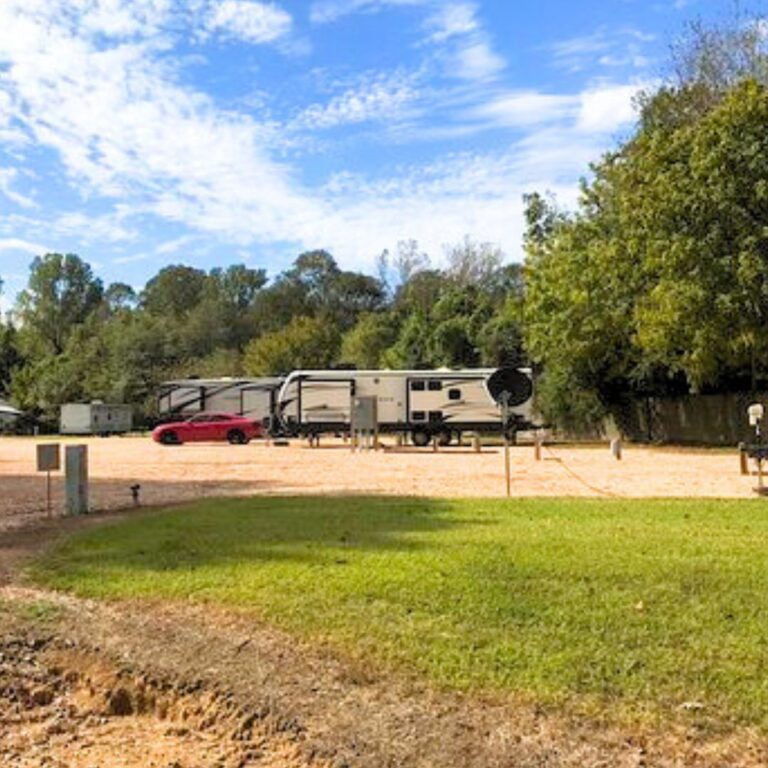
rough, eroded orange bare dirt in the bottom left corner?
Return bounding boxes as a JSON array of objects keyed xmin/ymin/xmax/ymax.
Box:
[{"xmin": 0, "ymin": 608, "xmax": 326, "ymax": 768}]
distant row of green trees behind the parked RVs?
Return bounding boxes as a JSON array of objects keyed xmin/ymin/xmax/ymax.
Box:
[{"xmin": 0, "ymin": 239, "xmax": 523, "ymax": 422}]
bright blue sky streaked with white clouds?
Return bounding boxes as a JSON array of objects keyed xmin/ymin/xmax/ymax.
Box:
[{"xmin": 0, "ymin": 0, "xmax": 727, "ymax": 306}]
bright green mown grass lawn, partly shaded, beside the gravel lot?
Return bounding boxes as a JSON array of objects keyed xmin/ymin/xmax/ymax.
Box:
[{"xmin": 31, "ymin": 498, "xmax": 768, "ymax": 728}]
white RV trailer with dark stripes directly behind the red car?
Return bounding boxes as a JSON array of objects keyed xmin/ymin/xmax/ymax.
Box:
[{"xmin": 158, "ymin": 378, "xmax": 283, "ymax": 426}]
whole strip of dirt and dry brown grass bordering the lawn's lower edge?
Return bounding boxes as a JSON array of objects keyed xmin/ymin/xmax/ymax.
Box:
[{"xmin": 0, "ymin": 588, "xmax": 768, "ymax": 768}]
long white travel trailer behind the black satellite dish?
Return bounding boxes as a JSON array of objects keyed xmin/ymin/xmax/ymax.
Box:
[{"xmin": 278, "ymin": 368, "xmax": 534, "ymax": 446}]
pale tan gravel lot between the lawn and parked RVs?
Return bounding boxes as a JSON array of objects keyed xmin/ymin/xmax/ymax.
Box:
[{"xmin": 0, "ymin": 437, "xmax": 756, "ymax": 526}]
